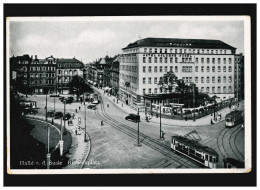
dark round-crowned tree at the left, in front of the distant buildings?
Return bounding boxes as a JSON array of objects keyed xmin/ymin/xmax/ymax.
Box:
[{"xmin": 69, "ymin": 75, "xmax": 93, "ymax": 101}]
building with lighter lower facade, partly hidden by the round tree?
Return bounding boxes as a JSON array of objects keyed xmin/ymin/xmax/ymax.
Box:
[{"xmin": 56, "ymin": 58, "xmax": 84, "ymax": 94}]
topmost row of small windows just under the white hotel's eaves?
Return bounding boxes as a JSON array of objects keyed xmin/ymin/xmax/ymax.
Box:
[{"xmin": 144, "ymin": 47, "xmax": 227, "ymax": 54}]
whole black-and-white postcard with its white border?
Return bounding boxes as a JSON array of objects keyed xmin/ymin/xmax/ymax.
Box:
[{"xmin": 6, "ymin": 11, "xmax": 252, "ymax": 174}]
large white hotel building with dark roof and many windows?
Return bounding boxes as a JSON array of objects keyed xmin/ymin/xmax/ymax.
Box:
[{"xmin": 119, "ymin": 38, "xmax": 236, "ymax": 107}]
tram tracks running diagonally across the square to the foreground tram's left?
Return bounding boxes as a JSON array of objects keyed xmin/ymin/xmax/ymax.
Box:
[{"xmin": 95, "ymin": 93, "xmax": 201, "ymax": 168}]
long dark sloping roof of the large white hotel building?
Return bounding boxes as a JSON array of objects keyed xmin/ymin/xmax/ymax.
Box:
[{"xmin": 123, "ymin": 38, "xmax": 236, "ymax": 50}]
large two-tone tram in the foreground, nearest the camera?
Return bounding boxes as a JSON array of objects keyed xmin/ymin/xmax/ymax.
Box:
[{"xmin": 171, "ymin": 136, "xmax": 218, "ymax": 168}]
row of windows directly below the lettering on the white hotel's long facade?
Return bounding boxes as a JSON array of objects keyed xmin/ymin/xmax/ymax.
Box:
[{"xmin": 143, "ymin": 57, "xmax": 232, "ymax": 64}]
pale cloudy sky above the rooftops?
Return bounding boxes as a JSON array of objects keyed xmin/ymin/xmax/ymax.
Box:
[{"xmin": 9, "ymin": 19, "xmax": 244, "ymax": 63}]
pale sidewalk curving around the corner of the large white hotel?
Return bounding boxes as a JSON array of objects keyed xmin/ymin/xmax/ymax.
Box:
[{"xmin": 92, "ymin": 86, "xmax": 244, "ymax": 127}]
